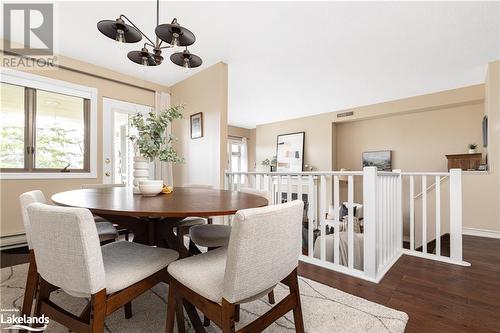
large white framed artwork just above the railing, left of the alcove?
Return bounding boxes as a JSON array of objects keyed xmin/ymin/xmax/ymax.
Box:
[{"xmin": 276, "ymin": 132, "xmax": 305, "ymax": 172}]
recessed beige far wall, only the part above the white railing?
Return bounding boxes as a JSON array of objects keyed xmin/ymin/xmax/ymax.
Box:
[{"xmin": 334, "ymin": 103, "xmax": 484, "ymax": 171}]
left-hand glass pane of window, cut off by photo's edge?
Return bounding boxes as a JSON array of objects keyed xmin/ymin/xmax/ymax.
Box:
[{"xmin": 0, "ymin": 83, "xmax": 25, "ymax": 168}]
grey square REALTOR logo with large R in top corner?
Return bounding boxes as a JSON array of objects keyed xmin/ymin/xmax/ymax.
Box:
[{"xmin": 3, "ymin": 3, "xmax": 56, "ymax": 69}]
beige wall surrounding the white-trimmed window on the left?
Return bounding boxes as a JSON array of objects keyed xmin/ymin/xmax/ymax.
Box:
[{"xmin": 0, "ymin": 50, "xmax": 169, "ymax": 237}]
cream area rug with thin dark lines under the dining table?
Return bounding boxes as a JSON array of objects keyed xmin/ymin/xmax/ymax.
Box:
[{"xmin": 0, "ymin": 264, "xmax": 408, "ymax": 333}]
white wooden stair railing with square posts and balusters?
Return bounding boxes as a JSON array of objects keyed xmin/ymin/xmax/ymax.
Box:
[{"xmin": 225, "ymin": 167, "xmax": 467, "ymax": 282}]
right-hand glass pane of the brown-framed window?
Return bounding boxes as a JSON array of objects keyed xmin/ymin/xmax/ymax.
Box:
[{"xmin": 35, "ymin": 90, "xmax": 85, "ymax": 169}]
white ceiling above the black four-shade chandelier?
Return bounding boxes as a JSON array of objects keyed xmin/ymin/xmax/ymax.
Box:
[{"xmin": 1, "ymin": 1, "xmax": 500, "ymax": 128}]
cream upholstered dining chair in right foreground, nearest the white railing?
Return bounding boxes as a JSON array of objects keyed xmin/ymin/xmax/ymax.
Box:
[{"xmin": 165, "ymin": 201, "xmax": 304, "ymax": 333}]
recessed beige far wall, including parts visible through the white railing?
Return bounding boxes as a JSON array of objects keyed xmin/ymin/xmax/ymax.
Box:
[{"xmin": 334, "ymin": 102, "xmax": 493, "ymax": 237}]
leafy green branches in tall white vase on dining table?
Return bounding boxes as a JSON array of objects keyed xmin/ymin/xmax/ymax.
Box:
[{"xmin": 129, "ymin": 105, "xmax": 184, "ymax": 193}]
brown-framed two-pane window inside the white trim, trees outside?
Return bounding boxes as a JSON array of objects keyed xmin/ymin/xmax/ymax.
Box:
[{"xmin": 0, "ymin": 82, "xmax": 90, "ymax": 172}]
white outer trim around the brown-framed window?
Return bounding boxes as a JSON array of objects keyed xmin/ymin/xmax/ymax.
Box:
[{"xmin": 0, "ymin": 68, "xmax": 97, "ymax": 179}]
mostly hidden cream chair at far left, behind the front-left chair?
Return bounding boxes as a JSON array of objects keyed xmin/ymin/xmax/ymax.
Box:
[{"xmin": 19, "ymin": 190, "xmax": 119, "ymax": 317}]
